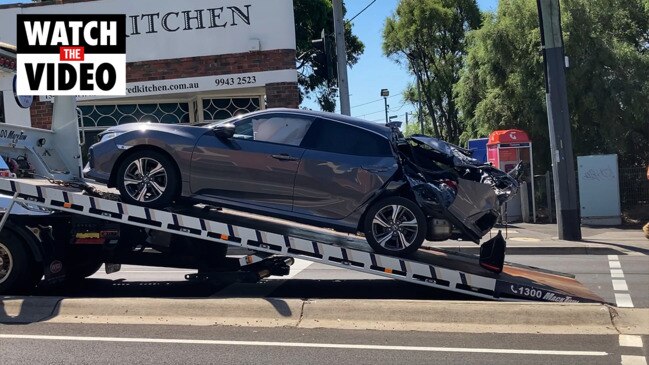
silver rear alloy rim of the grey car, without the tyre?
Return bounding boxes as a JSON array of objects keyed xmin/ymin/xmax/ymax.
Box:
[{"xmin": 372, "ymin": 205, "xmax": 419, "ymax": 251}]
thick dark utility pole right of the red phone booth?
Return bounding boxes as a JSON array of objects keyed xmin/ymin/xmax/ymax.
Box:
[{"xmin": 536, "ymin": 0, "xmax": 581, "ymax": 241}]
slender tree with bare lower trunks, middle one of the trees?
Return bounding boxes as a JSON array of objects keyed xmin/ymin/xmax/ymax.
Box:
[{"xmin": 383, "ymin": 0, "xmax": 480, "ymax": 143}]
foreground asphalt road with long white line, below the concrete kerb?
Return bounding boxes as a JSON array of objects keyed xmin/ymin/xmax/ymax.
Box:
[{"xmin": 0, "ymin": 323, "xmax": 649, "ymax": 365}]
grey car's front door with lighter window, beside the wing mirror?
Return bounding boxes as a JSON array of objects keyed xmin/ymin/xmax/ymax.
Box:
[{"xmin": 190, "ymin": 113, "xmax": 312, "ymax": 211}]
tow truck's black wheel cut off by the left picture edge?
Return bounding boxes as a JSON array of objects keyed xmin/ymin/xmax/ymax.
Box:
[{"xmin": 0, "ymin": 230, "xmax": 41, "ymax": 294}]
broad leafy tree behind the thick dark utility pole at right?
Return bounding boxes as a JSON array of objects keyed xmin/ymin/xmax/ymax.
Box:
[{"xmin": 456, "ymin": 0, "xmax": 649, "ymax": 169}]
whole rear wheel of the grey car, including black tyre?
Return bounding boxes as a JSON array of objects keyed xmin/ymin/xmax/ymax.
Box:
[{"xmin": 364, "ymin": 197, "xmax": 427, "ymax": 256}]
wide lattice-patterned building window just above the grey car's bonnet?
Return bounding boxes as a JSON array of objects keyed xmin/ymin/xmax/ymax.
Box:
[{"xmin": 79, "ymin": 102, "xmax": 189, "ymax": 128}]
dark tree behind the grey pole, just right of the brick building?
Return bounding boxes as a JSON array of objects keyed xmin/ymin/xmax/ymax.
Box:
[{"xmin": 293, "ymin": 0, "xmax": 365, "ymax": 111}]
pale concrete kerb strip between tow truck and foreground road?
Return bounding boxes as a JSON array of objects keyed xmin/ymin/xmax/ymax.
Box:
[{"xmin": 0, "ymin": 298, "xmax": 649, "ymax": 335}]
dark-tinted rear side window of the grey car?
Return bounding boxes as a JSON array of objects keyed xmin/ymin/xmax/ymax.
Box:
[{"xmin": 302, "ymin": 119, "xmax": 393, "ymax": 157}]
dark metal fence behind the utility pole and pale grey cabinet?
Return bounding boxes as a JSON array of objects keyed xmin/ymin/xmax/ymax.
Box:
[{"xmin": 534, "ymin": 167, "xmax": 649, "ymax": 222}]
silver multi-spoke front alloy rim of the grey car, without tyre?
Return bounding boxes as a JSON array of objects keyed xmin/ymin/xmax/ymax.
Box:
[{"xmin": 124, "ymin": 157, "xmax": 168, "ymax": 203}]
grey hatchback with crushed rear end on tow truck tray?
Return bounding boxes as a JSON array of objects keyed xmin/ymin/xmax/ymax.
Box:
[{"xmin": 85, "ymin": 109, "xmax": 518, "ymax": 255}]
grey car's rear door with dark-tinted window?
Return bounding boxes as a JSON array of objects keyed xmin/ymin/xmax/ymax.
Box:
[{"xmin": 293, "ymin": 119, "xmax": 398, "ymax": 219}]
